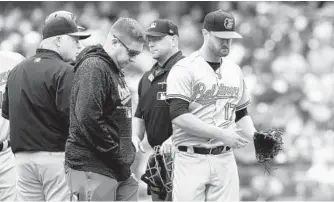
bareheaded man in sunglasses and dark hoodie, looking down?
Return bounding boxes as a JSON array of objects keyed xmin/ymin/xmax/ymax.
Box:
[{"xmin": 65, "ymin": 18, "xmax": 145, "ymax": 201}]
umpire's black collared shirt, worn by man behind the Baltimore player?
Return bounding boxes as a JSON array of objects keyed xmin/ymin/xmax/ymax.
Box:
[{"xmin": 135, "ymin": 51, "xmax": 184, "ymax": 147}]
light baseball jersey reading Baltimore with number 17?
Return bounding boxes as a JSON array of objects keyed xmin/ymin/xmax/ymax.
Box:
[{"xmin": 167, "ymin": 51, "xmax": 250, "ymax": 147}]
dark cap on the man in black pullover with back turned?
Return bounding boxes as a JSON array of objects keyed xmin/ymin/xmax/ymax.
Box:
[{"xmin": 42, "ymin": 16, "xmax": 90, "ymax": 40}]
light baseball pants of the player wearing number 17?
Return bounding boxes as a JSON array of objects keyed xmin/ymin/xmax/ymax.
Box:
[{"xmin": 173, "ymin": 149, "xmax": 240, "ymax": 201}]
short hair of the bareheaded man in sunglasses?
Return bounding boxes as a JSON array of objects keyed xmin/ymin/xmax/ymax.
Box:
[{"xmin": 108, "ymin": 18, "xmax": 145, "ymax": 44}]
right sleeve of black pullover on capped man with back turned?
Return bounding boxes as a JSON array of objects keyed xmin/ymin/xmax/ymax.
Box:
[{"xmin": 55, "ymin": 67, "xmax": 74, "ymax": 119}]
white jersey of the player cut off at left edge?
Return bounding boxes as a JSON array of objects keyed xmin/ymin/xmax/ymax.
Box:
[{"xmin": 0, "ymin": 51, "xmax": 24, "ymax": 142}]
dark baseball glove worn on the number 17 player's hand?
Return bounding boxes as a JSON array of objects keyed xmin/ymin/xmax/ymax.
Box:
[{"xmin": 254, "ymin": 129, "xmax": 283, "ymax": 173}]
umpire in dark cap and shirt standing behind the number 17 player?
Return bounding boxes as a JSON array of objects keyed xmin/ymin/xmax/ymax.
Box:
[{"xmin": 132, "ymin": 19, "xmax": 184, "ymax": 201}]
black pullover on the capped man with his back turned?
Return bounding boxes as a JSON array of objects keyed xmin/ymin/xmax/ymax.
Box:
[{"xmin": 2, "ymin": 49, "xmax": 73, "ymax": 153}]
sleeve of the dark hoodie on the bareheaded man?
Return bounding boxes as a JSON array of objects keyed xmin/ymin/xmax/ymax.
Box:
[{"xmin": 73, "ymin": 58, "xmax": 119, "ymax": 157}]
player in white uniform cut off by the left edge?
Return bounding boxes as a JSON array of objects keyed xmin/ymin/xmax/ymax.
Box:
[{"xmin": 0, "ymin": 51, "xmax": 24, "ymax": 201}]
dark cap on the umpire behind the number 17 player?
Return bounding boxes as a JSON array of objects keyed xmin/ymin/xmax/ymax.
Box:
[{"xmin": 146, "ymin": 19, "xmax": 179, "ymax": 36}]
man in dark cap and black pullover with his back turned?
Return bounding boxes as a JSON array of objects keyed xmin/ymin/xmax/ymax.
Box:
[{"xmin": 2, "ymin": 17, "xmax": 90, "ymax": 201}]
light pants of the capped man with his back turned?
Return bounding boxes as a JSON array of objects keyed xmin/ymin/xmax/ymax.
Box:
[{"xmin": 15, "ymin": 152, "xmax": 70, "ymax": 201}]
